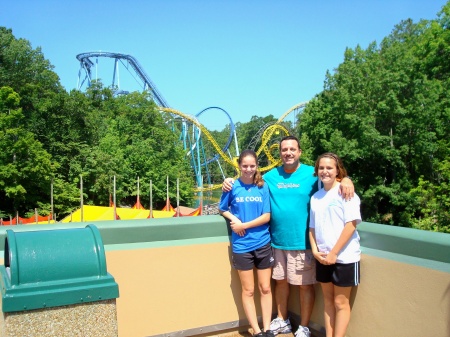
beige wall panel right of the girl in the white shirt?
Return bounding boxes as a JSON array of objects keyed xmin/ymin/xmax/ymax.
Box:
[{"xmin": 348, "ymin": 255, "xmax": 450, "ymax": 337}]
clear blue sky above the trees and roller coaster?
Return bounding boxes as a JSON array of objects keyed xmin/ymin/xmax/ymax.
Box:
[{"xmin": 0, "ymin": 0, "xmax": 446, "ymax": 130}]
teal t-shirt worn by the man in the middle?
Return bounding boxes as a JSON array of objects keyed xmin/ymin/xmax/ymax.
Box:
[{"xmin": 263, "ymin": 164, "xmax": 318, "ymax": 250}]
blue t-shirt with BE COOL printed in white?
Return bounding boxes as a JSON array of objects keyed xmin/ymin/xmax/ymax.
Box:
[{"xmin": 219, "ymin": 179, "xmax": 270, "ymax": 253}]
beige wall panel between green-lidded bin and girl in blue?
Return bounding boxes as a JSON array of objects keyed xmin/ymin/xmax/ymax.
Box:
[{"xmin": 106, "ymin": 243, "xmax": 253, "ymax": 337}]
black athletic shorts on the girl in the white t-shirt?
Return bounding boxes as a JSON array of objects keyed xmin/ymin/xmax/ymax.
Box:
[{"xmin": 316, "ymin": 261, "xmax": 360, "ymax": 287}]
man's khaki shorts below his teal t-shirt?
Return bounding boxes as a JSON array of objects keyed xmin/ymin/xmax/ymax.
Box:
[{"xmin": 272, "ymin": 248, "xmax": 317, "ymax": 286}]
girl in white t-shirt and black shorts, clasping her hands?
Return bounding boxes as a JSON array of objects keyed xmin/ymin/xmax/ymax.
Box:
[{"xmin": 309, "ymin": 153, "xmax": 361, "ymax": 337}]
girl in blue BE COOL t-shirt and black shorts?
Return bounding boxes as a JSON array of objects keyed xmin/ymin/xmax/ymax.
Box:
[{"xmin": 219, "ymin": 150, "xmax": 274, "ymax": 337}]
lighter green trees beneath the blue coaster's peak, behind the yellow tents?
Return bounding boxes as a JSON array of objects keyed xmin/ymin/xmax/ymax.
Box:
[{"xmin": 69, "ymin": 83, "xmax": 193, "ymax": 207}]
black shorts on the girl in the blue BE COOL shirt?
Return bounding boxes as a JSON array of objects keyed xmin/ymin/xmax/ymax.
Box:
[{"xmin": 231, "ymin": 242, "xmax": 275, "ymax": 270}]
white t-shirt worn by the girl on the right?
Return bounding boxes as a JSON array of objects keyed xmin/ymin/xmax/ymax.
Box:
[{"xmin": 309, "ymin": 184, "xmax": 361, "ymax": 263}]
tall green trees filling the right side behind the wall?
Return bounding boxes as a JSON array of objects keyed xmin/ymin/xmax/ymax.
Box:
[{"xmin": 299, "ymin": 4, "xmax": 450, "ymax": 231}]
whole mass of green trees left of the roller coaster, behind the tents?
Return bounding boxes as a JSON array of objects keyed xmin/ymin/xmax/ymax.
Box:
[{"xmin": 0, "ymin": 27, "xmax": 193, "ymax": 219}]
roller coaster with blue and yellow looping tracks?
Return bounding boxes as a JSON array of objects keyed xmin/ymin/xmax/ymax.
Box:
[{"xmin": 76, "ymin": 51, "xmax": 306, "ymax": 191}]
